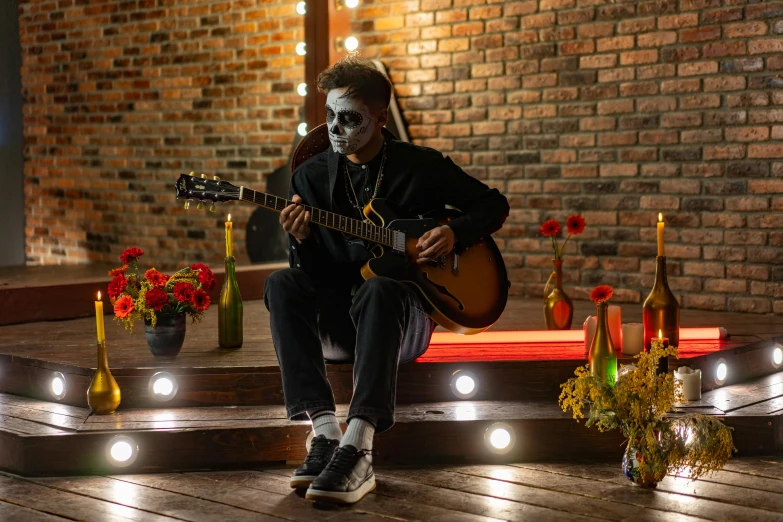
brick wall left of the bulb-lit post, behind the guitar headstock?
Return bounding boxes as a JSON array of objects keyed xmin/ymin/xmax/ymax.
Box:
[{"xmin": 19, "ymin": 0, "xmax": 304, "ymax": 268}]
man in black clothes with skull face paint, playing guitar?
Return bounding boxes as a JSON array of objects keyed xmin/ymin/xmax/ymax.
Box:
[{"xmin": 264, "ymin": 57, "xmax": 509, "ymax": 503}]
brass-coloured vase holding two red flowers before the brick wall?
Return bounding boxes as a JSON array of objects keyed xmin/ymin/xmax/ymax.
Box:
[{"xmin": 538, "ymin": 215, "xmax": 586, "ymax": 330}]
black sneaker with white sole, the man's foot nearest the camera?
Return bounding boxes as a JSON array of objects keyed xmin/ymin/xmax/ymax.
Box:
[{"xmin": 305, "ymin": 446, "xmax": 375, "ymax": 504}]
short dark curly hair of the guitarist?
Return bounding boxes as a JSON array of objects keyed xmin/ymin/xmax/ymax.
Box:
[{"xmin": 318, "ymin": 55, "xmax": 392, "ymax": 111}]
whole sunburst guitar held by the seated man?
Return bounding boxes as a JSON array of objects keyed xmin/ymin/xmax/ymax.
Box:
[{"xmin": 177, "ymin": 174, "xmax": 509, "ymax": 334}]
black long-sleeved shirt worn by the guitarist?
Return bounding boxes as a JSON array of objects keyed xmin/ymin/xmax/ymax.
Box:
[{"xmin": 288, "ymin": 139, "xmax": 509, "ymax": 291}]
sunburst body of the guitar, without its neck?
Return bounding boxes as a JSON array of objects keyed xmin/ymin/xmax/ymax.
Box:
[{"xmin": 362, "ymin": 199, "xmax": 508, "ymax": 334}]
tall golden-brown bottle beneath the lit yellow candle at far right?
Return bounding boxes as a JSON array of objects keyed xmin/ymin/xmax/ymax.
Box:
[{"xmin": 642, "ymin": 256, "xmax": 680, "ymax": 352}]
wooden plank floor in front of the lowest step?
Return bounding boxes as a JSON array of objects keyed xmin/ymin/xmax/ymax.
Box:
[{"xmin": 0, "ymin": 456, "xmax": 783, "ymax": 522}]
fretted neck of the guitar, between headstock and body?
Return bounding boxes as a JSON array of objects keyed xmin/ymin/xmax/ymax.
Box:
[{"xmin": 239, "ymin": 187, "xmax": 394, "ymax": 247}]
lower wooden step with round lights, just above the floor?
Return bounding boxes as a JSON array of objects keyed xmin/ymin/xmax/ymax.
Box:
[{"xmin": 0, "ymin": 372, "xmax": 783, "ymax": 475}]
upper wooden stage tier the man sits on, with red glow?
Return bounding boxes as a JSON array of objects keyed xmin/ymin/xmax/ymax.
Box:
[{"xmin": 0, "ymin": 299, "xmax": 783, "ymax": 409}]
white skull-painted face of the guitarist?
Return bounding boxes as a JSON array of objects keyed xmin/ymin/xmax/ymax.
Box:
[{"xmin": 326, "ymin": 87, "xmax": 375, "ymax": 154}]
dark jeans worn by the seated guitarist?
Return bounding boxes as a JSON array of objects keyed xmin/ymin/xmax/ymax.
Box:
[{"xmin": 264, "ymin": 268, "xmax": 435, "ymax": 433}]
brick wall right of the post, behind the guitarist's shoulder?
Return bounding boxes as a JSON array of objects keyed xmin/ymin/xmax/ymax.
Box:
[{"xmin": 352, "ymin": 0, "xmax": 783, "ymax": 313}]
